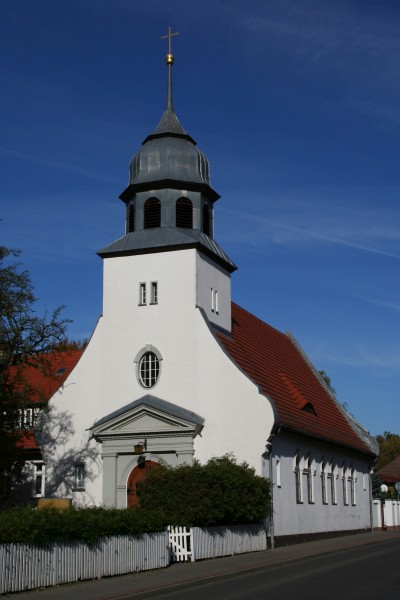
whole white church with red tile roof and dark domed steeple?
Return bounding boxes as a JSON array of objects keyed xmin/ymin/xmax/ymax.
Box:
[{"xmin": 24, "ymin": 47, "xmax": 377, "ymax": 539}]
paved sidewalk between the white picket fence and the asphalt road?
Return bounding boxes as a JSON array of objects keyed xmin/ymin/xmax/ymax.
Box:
[{"xmin": 6, "ymin": 531, "xmax": 400, "ymax": 600}]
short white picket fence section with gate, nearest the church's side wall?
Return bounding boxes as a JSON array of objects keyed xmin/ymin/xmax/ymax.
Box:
[{"xmin": 168, "ymin": 525, "xmax": 267, "ymax": 562}]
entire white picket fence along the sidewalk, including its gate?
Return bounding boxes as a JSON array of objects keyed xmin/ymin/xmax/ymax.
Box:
[{"xmin": 0, "ymin": 525, "xmax": 267, "ymax": 594}]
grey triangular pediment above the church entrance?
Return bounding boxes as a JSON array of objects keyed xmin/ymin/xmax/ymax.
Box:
[{"xmin": 91, "ymin": 395, "xmax": 204, "ymax": 439}]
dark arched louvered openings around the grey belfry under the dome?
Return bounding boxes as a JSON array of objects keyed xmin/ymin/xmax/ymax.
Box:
[{"xmin": 128, "ymin": 198, "xmax": 211, "ymax": 236}]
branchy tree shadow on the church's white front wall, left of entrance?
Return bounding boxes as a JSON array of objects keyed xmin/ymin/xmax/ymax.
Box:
[{"xmin": 36, "ymin": 408, "xmax": 101, "ymax": 504}]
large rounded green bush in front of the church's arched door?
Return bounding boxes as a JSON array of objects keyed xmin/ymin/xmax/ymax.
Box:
[{"xmin": 139, "ymin": 456, "xmax": 270, "ymax": 527}]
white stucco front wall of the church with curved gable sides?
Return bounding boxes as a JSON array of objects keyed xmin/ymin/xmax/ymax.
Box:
[{"xmin": 44, "ymin": 249, "xmax": 274, "ymax": 504}]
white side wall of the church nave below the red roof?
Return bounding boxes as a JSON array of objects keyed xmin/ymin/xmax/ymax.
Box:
[{"xmin": 272, "ymin": 433, "xmax": 371, "ymax": 536}]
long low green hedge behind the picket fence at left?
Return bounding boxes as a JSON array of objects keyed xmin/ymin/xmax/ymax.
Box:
[{"xmin": 0, "ymin": 508, "xmax": 167, "ymax": 545}]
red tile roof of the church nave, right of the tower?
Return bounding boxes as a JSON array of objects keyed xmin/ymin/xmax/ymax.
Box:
[{"xmin": 216, "ymin": 303, "xmax": 375, "ymax": 455}]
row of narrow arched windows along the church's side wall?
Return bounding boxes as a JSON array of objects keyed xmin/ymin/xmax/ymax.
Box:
[{"xmin": 290, "ymin": 455, "xmax": 365, "ymax": 506}]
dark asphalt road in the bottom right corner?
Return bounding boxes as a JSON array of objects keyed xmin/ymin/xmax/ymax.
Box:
[{"xmin": 135, "ymin": 539, "xmax": 400, "ymax": 600}]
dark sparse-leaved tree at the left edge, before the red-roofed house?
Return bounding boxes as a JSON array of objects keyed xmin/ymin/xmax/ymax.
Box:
[{"xmin": 0, "ymin": 246, "xmax": 70, "ymax": 507}]
